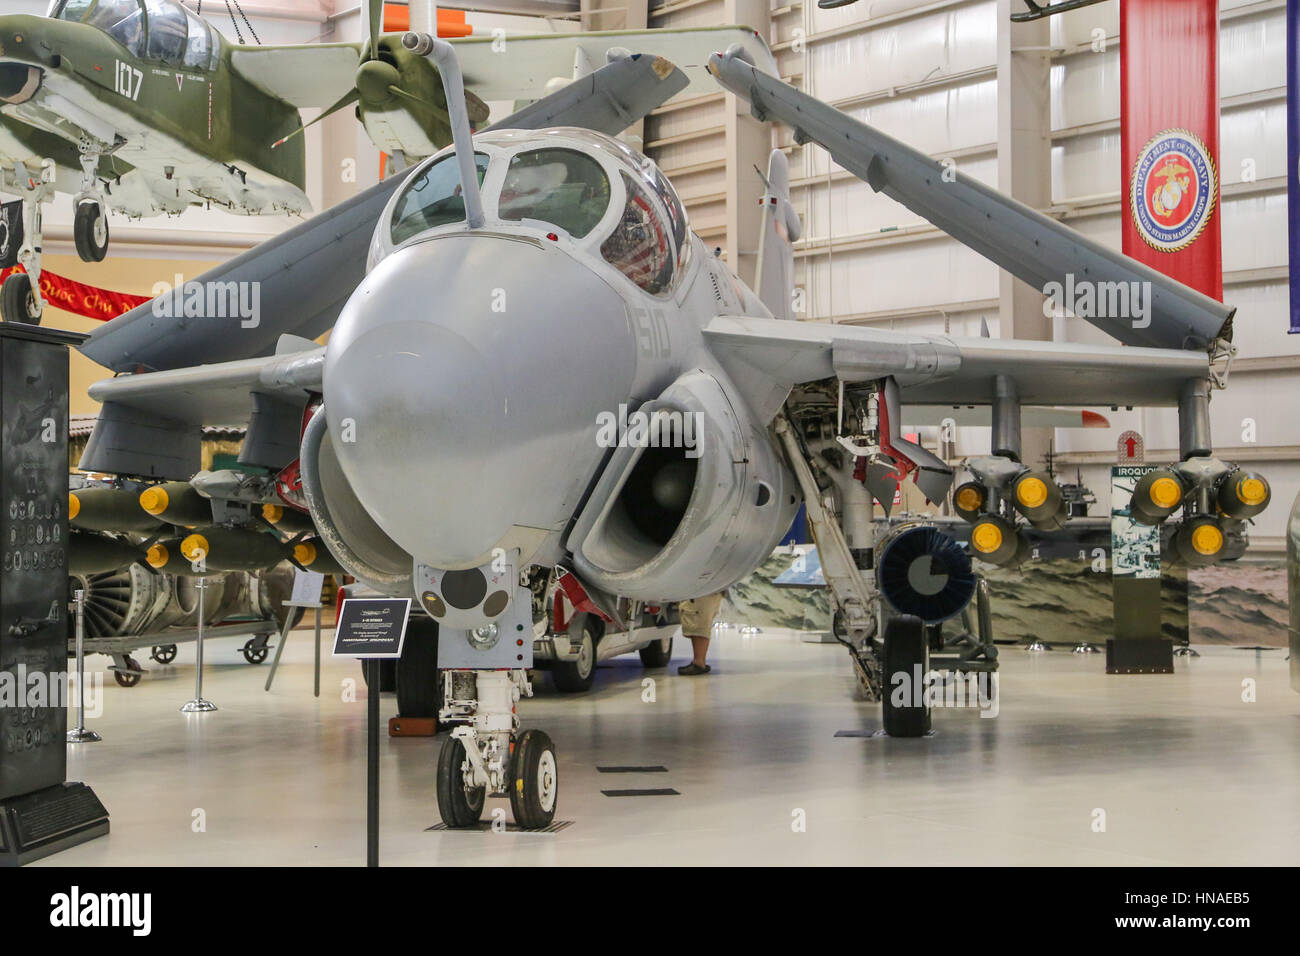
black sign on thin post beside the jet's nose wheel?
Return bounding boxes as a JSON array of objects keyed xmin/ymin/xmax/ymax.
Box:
[{"xmin": 333, "ymin": 597, "xmax": 411, "ymax": 866}]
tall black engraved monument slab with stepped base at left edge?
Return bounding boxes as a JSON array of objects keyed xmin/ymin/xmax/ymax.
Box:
[{"xmin": 0, "ymin": 323, "xmax": 108, "ymax": 866}]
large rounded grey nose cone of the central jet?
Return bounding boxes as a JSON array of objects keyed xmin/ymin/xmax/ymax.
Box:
[{"xmin": 324, "ymin": 235, "xmax": 636, "ymax": 568}]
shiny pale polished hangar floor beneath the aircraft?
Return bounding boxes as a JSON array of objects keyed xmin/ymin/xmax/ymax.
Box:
[{"xmin": 40, "ymin": 630, "xmax": 1300, "ymax": 865}]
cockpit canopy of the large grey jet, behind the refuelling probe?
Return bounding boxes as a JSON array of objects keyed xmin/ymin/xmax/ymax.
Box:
[{"xmin": 371, "ymin": 127, "xmax": 690, "ymax": 295}]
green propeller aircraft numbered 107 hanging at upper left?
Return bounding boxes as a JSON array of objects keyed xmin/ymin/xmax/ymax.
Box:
[{"xmin": 0, "ymin": 0, "xmax": 771, "ymax": 323}]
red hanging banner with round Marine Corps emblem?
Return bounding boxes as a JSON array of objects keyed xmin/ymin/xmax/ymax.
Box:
[{"xmin": 1119, "ymin": 0, "xmax": 1223, "ymax": 299}]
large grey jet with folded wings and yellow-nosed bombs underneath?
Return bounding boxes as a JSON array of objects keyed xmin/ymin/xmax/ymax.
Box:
[{"xmin": 68, "ymin": 34, "xmax": 1269, "ymax": 826}]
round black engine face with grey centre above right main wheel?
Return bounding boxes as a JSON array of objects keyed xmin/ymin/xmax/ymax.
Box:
[{"xmin": 876, "ymin": 524, "xmax": 975, "ymax": 624}]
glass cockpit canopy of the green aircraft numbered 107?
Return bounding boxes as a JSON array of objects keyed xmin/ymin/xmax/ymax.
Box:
[{"xmin": 53, "ymin": 0, "xmax": 217, "ymax": 70}]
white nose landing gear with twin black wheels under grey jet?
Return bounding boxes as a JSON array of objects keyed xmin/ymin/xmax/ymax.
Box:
[{"xmin": 438, "ymin": 670, "xmax": 559, "ymax": 830}]
